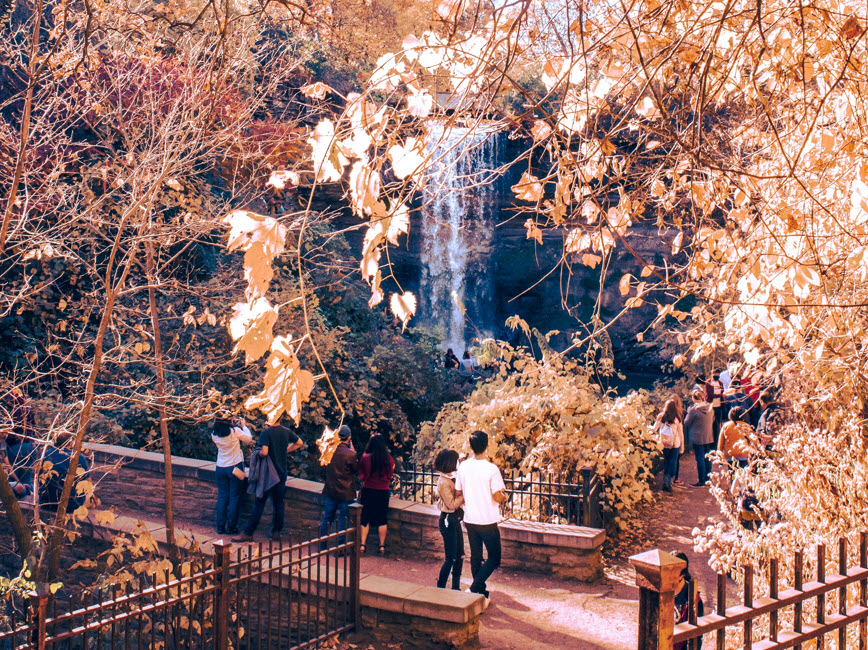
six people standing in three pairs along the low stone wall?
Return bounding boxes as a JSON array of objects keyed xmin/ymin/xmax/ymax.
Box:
[{"xmin": 211, "ymin": 418, "xmax": 507, "ymax": 602}]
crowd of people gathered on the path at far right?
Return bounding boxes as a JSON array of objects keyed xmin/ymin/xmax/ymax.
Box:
[{"xmin": 654, "ymin": 369, "xmax": 781, "ymax": 527}]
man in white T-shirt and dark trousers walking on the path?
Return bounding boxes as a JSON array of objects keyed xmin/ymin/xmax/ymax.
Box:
[{"xmin": 455, "ymin": 431, "xmax": 506, "ymax": 598}]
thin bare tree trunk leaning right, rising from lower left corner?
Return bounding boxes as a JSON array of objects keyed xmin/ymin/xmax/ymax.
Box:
[{"xmin": 36, "ymin": 240, "xmax": 138, "ymax": 582}]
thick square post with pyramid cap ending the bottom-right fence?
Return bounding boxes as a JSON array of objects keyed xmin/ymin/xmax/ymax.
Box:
[{"xmin": 630, "ymin": 549, "xmax": 687, "ymax": 650}]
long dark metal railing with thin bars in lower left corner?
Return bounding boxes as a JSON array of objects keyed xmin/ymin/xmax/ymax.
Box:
[{"xmin": 0, "ymin": 505, "xmax": 361, "ymax": 650}]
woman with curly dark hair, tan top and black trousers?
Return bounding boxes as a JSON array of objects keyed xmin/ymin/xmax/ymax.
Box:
[{"xmin": 434, "ymin": 449, "xmax": 464, "ymax": 590}]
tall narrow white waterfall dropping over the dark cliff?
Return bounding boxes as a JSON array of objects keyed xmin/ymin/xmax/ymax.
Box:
[{"xmin": 419, "ymin": 124, "xmax": 498, "ymax": 356}]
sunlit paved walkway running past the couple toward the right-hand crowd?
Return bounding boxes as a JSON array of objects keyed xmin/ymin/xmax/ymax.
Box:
[{"xmin": 362, "ymin": 454, "xmax": 736, "ymax": 650}]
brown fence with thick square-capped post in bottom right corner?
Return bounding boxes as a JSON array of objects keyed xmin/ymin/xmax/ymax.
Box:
[{"xmin": 630, "ymin": 532, "xmax": 868, "ymax": 650}]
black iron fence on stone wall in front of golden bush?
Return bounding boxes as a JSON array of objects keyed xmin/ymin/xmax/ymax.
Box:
[{"xmin": 393, "ymin": 463, "xmax": 603, "ymax": 528}]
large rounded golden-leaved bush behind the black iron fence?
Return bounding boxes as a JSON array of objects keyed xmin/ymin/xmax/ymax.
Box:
[{"xmin": 416, "ymin": 341, "xmax": 659, "ymax": 528}]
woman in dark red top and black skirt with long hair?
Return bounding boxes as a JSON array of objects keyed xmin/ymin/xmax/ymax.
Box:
[{"xmin": 359, "ymin": 434, "xmax": 395, "ymax": 555}]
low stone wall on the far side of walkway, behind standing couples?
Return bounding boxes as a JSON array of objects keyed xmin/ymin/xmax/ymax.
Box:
[{"xmin": 88, "ymin": 444, "xmax": 605, "ymax": 582}]
